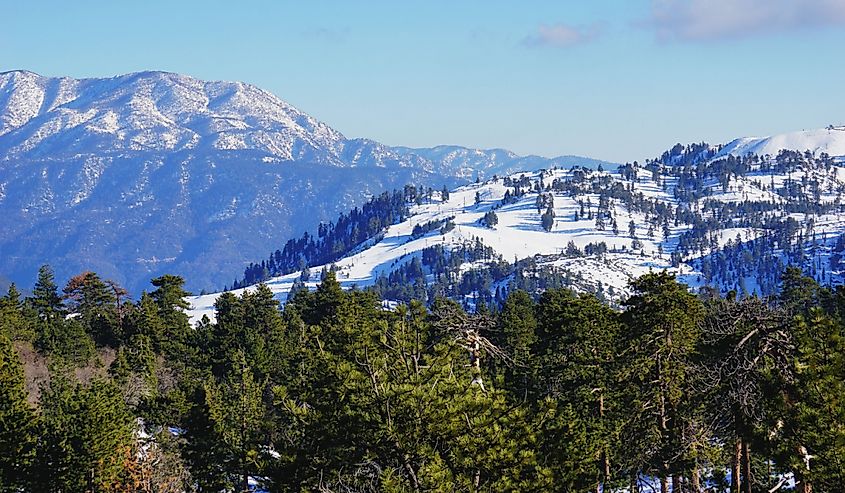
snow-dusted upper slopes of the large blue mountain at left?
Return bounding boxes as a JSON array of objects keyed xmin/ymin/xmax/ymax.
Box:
[{"xmin": 0, "ymin": 71, "xmax": 380, "ymax": 165}]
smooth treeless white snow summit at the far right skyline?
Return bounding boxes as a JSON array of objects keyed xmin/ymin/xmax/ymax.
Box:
[{"xmin": 718, "ymin": 126, "xmax": 845, "ymax": 160}]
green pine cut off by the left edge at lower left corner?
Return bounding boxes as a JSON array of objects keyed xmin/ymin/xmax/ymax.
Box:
[{"xmin": 0, "ymin": 334, "xmax": 38, "ymax": 493}]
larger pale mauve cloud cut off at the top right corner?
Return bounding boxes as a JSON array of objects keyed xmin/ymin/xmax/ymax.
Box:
[{"xmin": 646, "ymin": 0, "xmax": 845, "ymax": 41}]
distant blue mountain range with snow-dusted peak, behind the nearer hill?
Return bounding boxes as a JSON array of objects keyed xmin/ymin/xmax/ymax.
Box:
[{"xmin": 0, "ymin": 71, "xmax": 615, "ymax": 294}]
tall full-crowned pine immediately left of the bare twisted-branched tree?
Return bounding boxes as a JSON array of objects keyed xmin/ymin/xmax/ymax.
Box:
[{"xmin": 621, "ymin": 272, "xmax": 703, "ymax": 493}]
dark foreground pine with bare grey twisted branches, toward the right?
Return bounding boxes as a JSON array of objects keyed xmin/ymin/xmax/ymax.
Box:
[{"xmin": 697, "ymin": 294, "xmax": 792, "ymax": 492}]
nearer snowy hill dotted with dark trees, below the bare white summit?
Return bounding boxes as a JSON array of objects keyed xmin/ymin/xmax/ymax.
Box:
[{"xmin": 190, "ymin": 148, "xmax": 845, "ymax": 320}]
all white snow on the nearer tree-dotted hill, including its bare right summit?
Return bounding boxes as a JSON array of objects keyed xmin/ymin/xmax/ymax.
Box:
[{"xmin": 190, "ymin": 127, "xmax": 845, "ymax": 321}]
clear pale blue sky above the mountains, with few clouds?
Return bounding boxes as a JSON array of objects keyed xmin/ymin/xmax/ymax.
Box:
[{"xmin": 0, "ymin": 0, "xmax": 845, "ymax": 161}]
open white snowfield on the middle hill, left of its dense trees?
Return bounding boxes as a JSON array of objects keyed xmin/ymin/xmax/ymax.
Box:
[{"xmin": 189, "ymin": 169, "xmax": 697, "ymax": 321}]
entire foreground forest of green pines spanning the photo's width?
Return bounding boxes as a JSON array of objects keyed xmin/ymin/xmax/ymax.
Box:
[{"xmin": 0, "ymin": 269, "xmax": 845, "ymax": 493}]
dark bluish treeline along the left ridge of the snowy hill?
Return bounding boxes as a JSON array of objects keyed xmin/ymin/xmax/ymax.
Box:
[{"xmin": 231, "ymin": 185, "xmax": 449, "ymax": 289}]
